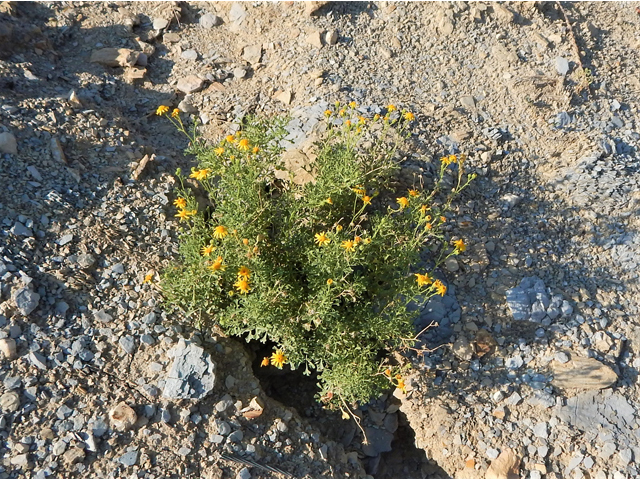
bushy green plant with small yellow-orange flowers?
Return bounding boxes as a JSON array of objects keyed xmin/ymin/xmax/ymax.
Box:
[{"xmin": 162, "ymin": 103, "xmax": 473, "ymax": 408}]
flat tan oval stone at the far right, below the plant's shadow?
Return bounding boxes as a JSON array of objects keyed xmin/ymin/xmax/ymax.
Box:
[{"xmin": 551, "ymin": 357, "xmax": 618, "ymax": 390}]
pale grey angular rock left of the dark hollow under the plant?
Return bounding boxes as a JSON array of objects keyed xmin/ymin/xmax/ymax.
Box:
[{"xmin": 162, "ymin": 340, "xmax": 216, "ymax": 399}]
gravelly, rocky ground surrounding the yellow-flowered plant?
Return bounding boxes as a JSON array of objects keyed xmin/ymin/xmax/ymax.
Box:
[{"xmin": 0, "ymin": 2, "xmax": 640, "ymax": 478}]
